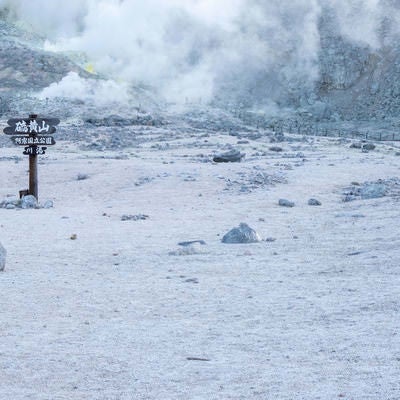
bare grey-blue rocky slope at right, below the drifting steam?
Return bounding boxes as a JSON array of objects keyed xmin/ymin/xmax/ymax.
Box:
[{"xmin": 315, "ymin": 6, "xmax": 400, "ymax": 120}]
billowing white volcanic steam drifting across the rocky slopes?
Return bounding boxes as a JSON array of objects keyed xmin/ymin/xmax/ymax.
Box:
[{"xmin": 0, "ymin": 0, "xmax": 400, "ymax": 107}]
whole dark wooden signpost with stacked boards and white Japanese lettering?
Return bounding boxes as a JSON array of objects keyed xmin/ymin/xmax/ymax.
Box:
[{"xmin": 3, "ymin": 114, "xmax": 60, "ymax": 200}]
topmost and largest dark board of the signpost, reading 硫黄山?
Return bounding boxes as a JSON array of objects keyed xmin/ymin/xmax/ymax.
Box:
[{"xmin": 3, "ymin": 118, "xmax": 60, "ymax": 135}]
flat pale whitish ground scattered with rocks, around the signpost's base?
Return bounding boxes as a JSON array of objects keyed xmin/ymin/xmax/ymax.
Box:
[{"xmin": 0, "ymin": 128, "xmax": 400, "ymax": 400}]
